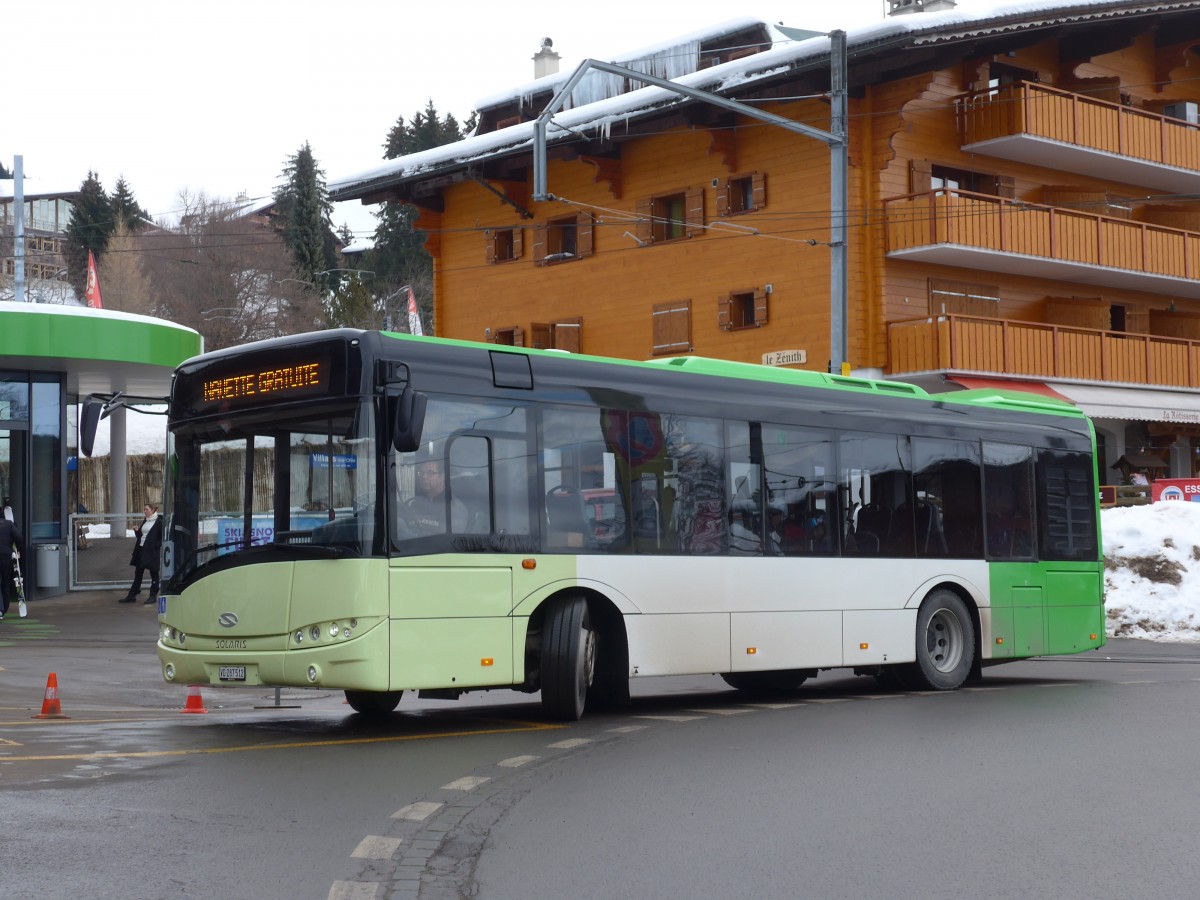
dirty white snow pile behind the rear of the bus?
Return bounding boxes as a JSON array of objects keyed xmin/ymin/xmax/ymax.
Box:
[{"xmin": 1100, "ymin": 500, "xmax": 1200, "ymax": 642}]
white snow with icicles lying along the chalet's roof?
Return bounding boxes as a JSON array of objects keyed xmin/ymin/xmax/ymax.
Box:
[{"xmin": 329, "ymin": 0, "xmax": 1200, "ymax": 199}]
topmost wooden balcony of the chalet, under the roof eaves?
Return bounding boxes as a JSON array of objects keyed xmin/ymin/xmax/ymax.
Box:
[{"xmin": 955, "ymin": 82, "xmax": 1200, "ymax": 193}]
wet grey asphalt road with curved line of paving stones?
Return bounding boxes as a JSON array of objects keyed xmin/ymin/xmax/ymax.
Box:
[{"xmin": 0, "ymin": 592, "xmax": 1200, "ymax": 900}]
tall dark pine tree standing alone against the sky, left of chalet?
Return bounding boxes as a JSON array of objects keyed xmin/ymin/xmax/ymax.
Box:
[{"xmin": 275, "ymin": 142, "xmax": 337, "ymax": 293}]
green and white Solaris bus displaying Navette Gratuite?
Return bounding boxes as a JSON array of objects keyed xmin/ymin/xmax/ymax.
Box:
[{"xmin": 145, "ymin": 330, "xmax": 1104, "ymax": 720}]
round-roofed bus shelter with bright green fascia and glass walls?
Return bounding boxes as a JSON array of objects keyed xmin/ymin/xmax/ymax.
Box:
[{"xmin": 0, "ymin": 301, "xmax": 203, "ymax": 600}]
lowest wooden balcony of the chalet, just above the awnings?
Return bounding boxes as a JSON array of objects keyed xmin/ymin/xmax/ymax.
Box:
[{"xmin": 887, "ymin": 313, "xmax": 1200, "ymax": 388}]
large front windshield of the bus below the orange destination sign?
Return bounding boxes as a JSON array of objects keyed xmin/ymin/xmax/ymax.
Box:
[{"xmin": 163, "ymin": 397, "xmax": 376, "ymax": 583}]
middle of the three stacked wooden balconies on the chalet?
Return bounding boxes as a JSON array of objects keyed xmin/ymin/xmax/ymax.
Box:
[{"xmin": 883, "ymin": 187, "xmax": 1200, "ymax": 299}]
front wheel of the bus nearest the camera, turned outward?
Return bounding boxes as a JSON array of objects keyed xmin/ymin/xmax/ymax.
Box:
[{"xmin": 541, "ymin": 596, "xmax": 596, "ymax": 721}]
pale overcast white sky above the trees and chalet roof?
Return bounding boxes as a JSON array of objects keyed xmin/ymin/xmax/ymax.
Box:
[{"xmin": 7, "ymin": 0, "xmax": 892, "ymax": 243}]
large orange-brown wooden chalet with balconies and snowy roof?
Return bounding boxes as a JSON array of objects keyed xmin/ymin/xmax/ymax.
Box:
[{"xmin": 330, "ymin": 0, "xmax": 1200, "ymax": 480}]
